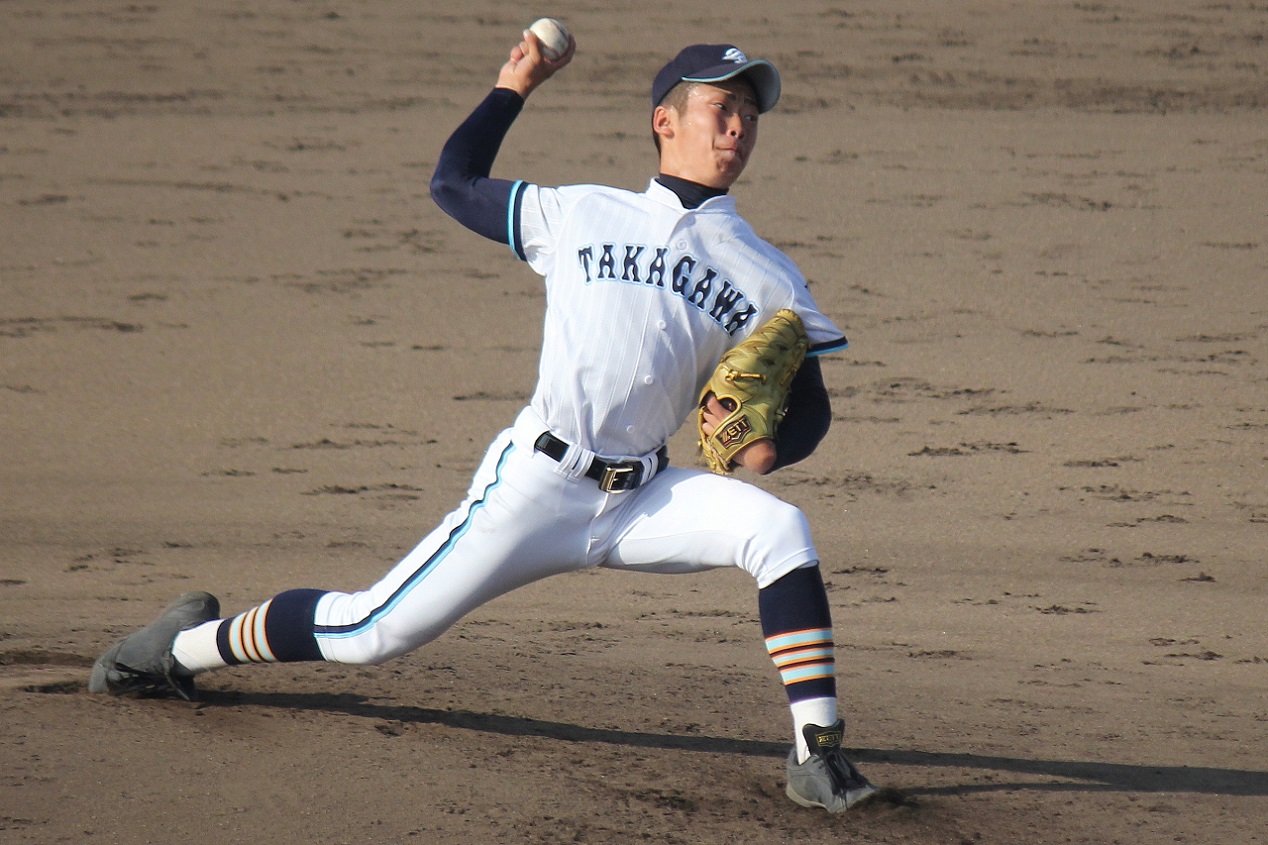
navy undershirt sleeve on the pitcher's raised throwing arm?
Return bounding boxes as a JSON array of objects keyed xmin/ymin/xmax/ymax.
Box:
[{"xmin": 431, "ymin": 88, "xmax": 524, "ymax": 244}]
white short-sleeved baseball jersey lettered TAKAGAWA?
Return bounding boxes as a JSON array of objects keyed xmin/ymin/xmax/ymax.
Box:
[{"xmin": 511, "ymin": 173, "xmax": 846, "ymax": 457}]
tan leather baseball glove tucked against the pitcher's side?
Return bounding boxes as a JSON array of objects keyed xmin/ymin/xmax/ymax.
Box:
[{"xmin": 696, "ymin": 308, "xmax": 810, "ymax": 475}]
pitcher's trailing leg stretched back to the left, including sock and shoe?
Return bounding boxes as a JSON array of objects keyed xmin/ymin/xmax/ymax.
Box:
[{"xmin": 90, "ymin": 423, "xmax": 600, "ymax": 698}]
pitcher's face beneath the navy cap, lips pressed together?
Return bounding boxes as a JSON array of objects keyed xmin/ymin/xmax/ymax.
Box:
[{"xmin": 653, "ymin": 79, "xmax": 758, "ymax": 189}]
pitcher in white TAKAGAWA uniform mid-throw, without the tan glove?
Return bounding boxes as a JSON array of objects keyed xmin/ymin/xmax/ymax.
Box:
[{"xmin": 89, "ymin": 32, "xmax": 876, "ymax": 812}]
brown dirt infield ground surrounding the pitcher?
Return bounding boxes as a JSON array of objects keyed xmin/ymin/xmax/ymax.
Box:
[{"xmin": 0, "ymin": 0, "xmax": 1268, "ymax": 845}]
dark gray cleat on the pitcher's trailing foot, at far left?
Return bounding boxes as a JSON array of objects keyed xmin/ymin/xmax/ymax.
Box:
[{"xmin": 87, "ymin": 591, "xmax": 221, "ymax": 702}]
